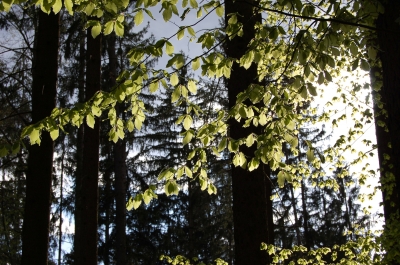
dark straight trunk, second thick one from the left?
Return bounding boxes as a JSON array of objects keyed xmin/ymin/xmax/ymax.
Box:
[{"xmin": 77, "ymin": 24, "xmax": 101, "ymax": 265}]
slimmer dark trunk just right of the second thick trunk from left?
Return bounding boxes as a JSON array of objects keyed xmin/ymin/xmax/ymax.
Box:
[{"xmin": 108, "ymin": 33, "xmax": 127, "ymax": 265}]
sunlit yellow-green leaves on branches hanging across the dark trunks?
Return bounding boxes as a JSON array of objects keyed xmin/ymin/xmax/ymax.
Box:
[{"xmin": 0, "ymin": 0, "xmax": 383, "ymax": 259}]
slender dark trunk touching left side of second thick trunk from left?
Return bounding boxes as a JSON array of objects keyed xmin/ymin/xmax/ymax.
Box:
[{"xmin": 74, "ymin": 25, "xmax": 86, "ymax": 264}]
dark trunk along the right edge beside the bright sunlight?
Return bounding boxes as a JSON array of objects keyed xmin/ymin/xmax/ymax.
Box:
[{"xmin": 376, "ymin": 0, "xmax": 400, "ymax": 264}]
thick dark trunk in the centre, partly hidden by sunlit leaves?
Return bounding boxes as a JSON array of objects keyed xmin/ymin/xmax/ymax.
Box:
[{"xmin": 225, "ymin": 0, "xmax": 273, "ymax": 265}]
